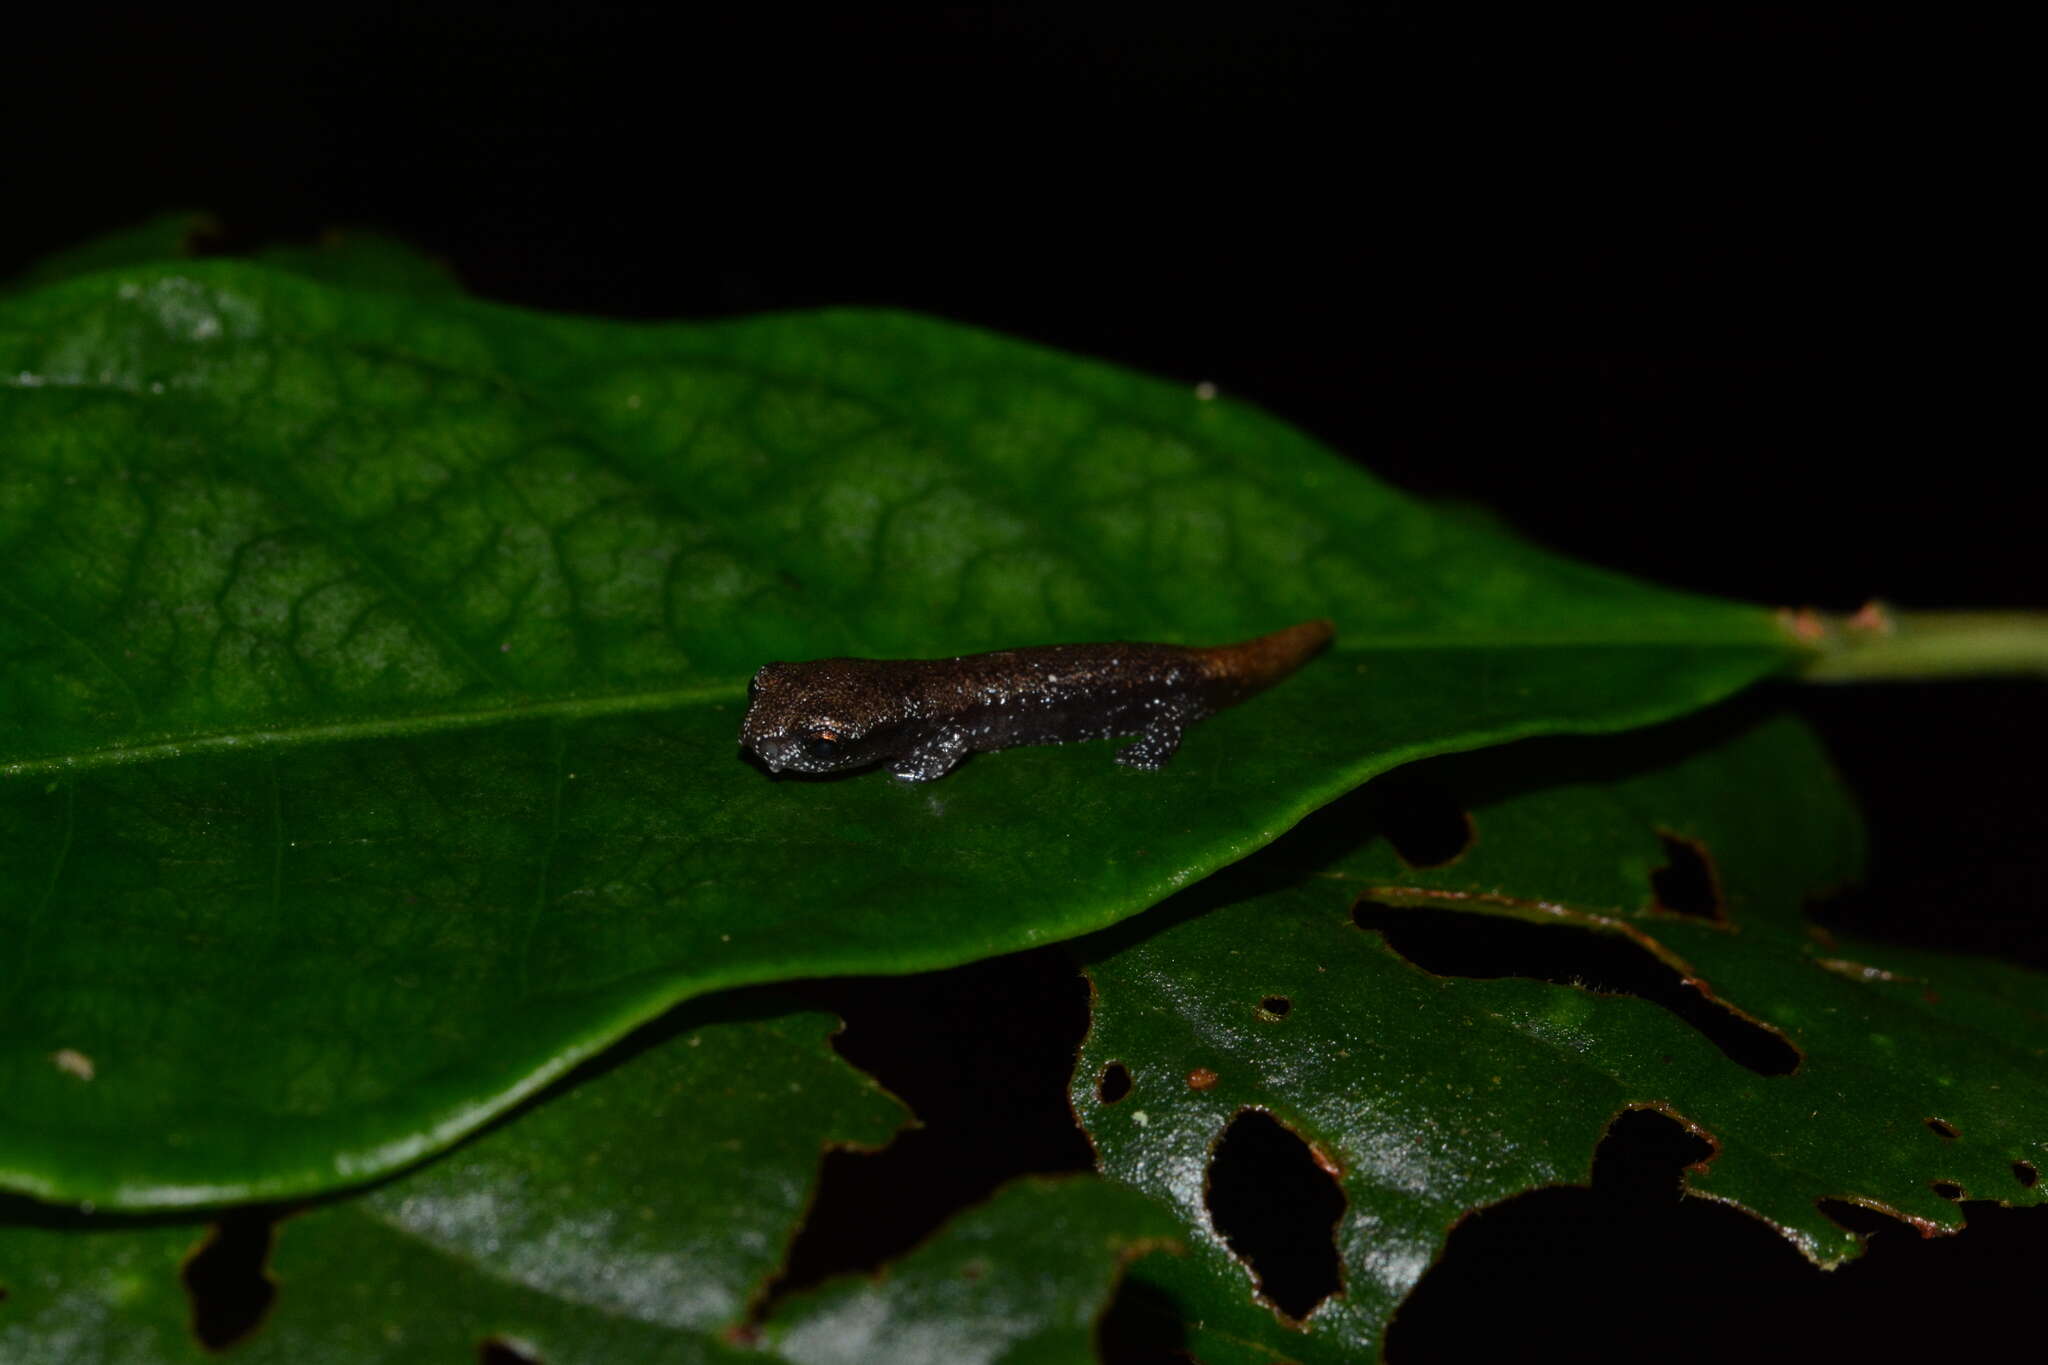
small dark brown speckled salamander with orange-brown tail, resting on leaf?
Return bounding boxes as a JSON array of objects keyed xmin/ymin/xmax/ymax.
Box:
[{"xmin": 739, "ymin": 620, "xmax": 1333, "ymax": 782}]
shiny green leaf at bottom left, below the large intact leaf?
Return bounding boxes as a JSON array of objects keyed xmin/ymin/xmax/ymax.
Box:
[{"xmin": 0, "ymin": 1005, "xmax": 1169, "ymax": 1365}]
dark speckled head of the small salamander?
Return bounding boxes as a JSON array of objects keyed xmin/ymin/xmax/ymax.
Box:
[{"xmin": 739, "ymin": 659, "xmax": 911, "ymax": 774}]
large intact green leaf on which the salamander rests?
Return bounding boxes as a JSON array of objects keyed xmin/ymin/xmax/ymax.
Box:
[{"xmin": 0, "ymin": 245, "xmax": 1796, "ymax": 1207}]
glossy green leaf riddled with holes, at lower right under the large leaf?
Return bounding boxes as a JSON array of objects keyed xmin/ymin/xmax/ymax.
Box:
[{"xmin": 1073, "ymin": 714, "xmax": 2048, "ymax": 1363}]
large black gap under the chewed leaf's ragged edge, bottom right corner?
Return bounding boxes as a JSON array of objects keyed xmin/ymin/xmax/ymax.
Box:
[{"xmin": 1386, "ymin": 1113, "xmax": 2048, "ymax": 1365}]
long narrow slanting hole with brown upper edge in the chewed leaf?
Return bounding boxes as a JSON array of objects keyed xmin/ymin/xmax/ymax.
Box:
[{"xmin": 1352, "ymin": 900, "xmax": 1798, "ymax": 1076}]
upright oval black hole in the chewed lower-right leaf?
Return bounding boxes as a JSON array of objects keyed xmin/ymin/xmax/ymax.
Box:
[{"xmin": 1204, "ymin": 1109, "xmax": 1343, "ymax": 1322}]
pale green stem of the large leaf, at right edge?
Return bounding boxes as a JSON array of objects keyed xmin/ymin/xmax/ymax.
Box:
[{"xmin": 1780, "ymin": 602, "xmax": 2048, "ymax": 681}]
